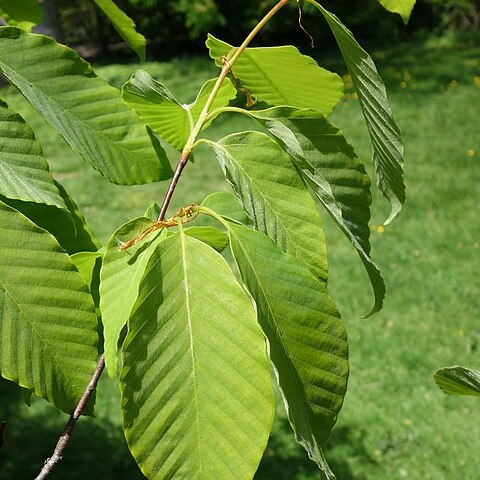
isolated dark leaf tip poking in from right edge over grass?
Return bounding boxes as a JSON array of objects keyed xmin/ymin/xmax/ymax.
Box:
[{"xmin": 433, "ymin": 366, "xmax": 480, "ymax": 397}]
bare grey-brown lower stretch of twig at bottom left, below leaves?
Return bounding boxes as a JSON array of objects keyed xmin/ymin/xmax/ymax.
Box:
[{"xmin": 35, "ymin": 354, "xmax": 105, "ymax": 480}]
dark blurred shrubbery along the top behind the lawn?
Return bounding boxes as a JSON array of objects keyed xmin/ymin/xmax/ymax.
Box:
[{"xmin": 39, "ymin": 0, "xmax": 480, "ymax": 59}]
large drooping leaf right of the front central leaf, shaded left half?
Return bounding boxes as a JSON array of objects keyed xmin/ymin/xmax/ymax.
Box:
[{"xmin": 229, "ymin": 224, "xmax": 348, "ymax": 479}]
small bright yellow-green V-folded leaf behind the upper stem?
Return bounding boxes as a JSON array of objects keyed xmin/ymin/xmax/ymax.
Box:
[{"xmin": 122, "ymin": 70, "xmax": 236, "ymax": 151}]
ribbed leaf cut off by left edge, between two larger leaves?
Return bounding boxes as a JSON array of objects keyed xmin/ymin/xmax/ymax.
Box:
[{"xmin": 0, "ymin": 100, "xmax": 65, "ymax": 208}]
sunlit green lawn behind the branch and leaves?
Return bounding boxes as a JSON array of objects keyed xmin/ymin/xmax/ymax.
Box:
[{"xmin": 0, "ymin": 43, "xmax": 480, "ymax": 480}]
